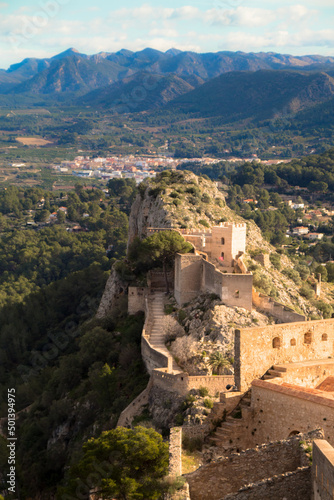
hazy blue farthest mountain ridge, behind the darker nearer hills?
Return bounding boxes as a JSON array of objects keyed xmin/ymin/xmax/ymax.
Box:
[{"xmin": 0, "ymin": 48, "xmax": 334, "ymax": 94}]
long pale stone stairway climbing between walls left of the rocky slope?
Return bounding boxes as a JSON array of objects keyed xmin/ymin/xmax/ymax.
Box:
[{"xmin": 148, "ymin": 292, "xmax": 182, "ymax": 373}]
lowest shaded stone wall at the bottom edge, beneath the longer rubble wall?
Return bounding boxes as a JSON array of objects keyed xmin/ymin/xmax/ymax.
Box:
[{"xmin": 224, "ymin": 467, "xmax": 310, "ymax": 500}]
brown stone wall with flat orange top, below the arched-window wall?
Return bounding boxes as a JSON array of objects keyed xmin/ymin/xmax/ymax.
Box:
[{"xmin": 249, "ymin": 380, "xmax": 334, "ymax": 444}]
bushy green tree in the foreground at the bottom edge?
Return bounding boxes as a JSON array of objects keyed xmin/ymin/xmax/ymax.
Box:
[{"xmin": 62, "ymin": 427, "xmax": 168, "ymax": 500}]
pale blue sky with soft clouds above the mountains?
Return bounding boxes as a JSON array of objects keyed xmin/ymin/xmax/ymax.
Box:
[{"xmin": 0, "ymin": 0, "xmax": 334, "ymax": 69}]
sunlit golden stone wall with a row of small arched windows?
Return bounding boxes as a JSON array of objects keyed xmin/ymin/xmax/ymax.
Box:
[{"xmin": 235, "ymin": 319, "xmax": 334, "ymax": 391}]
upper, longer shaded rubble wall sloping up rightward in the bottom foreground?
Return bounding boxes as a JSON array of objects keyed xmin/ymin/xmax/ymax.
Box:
[{"xmin": 185, "ymin": 436, "xmax": 307, "ymax": 500}]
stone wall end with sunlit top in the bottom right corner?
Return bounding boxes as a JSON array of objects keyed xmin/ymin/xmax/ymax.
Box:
[{"xmin": 312, "ymin": 439, "xmax": 334, "ymax": 500}]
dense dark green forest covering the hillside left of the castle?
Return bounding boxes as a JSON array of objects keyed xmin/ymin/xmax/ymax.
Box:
[{"xmin": 0, "ymin": 180, "xmax": 153, "ymax": 498}]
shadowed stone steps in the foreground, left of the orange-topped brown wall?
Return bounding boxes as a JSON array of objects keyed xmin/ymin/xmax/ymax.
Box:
[{"xmin": 209, "ymin": 391, "xmax": 251, "ymax": 449}]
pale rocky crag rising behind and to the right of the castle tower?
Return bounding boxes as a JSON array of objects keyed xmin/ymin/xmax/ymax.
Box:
[{"xmin": 98, "ymin": 171, "xmax": 332, "ymax": 319}]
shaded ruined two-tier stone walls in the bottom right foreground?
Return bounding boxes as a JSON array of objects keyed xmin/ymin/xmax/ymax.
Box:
[{"xmin": 186, "ymin": 431, "xmax": 323, "ymax": 500}]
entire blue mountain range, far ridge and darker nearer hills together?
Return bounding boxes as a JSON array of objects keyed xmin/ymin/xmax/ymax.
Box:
[{"xmin": 0, "ymin": 48, "xmax": 334, "ymax": 121}]
